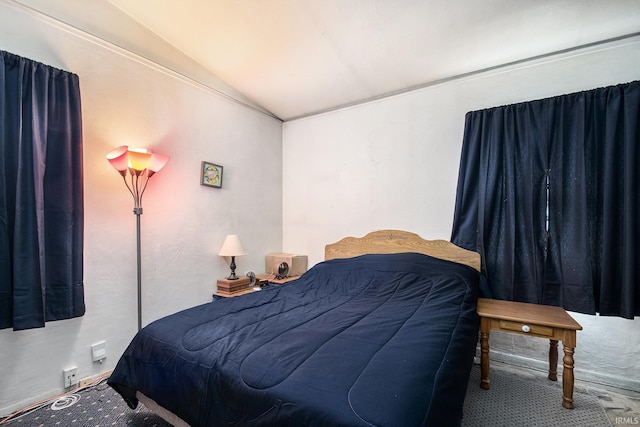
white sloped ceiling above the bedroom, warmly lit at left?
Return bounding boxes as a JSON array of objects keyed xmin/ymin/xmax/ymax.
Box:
[{"xmin": 8, "ymin": 0, "xmax": 640, "ymax": 121}]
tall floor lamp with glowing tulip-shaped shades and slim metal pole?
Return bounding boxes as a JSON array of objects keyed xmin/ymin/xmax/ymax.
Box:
[{"xmin": 107, "ymin": 145, "xmax": 169, "ymax": 331}]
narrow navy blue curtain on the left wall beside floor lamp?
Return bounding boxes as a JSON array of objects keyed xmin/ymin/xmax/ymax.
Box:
[{"xmin": 0, "ymin": 51, "xmax": 85, "ymax": 330}]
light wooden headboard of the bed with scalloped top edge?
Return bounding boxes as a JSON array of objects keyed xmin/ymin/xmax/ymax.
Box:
[{"xmin": 324, "ymin": 230, "xmax": 480, "ymax": 271}]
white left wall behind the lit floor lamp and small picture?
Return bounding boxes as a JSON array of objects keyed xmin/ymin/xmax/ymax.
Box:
[{"xmin": 0, "ymin": 2, "xmax": 282, "ymax": 416}]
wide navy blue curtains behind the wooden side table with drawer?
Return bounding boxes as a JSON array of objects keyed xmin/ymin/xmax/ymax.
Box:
[{"xmin": 451, "ymin": 82, "xmax": 640, "ymax": 319}]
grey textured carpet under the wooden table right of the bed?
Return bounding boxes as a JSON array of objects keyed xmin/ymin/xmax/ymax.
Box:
[{"xmin": 462, "ymin": 365, "xmax": 611, "ymax": 427}]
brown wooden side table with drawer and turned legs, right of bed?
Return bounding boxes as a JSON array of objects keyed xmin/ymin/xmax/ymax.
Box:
[{"xmin": 477, "ymin": 298, "xmax": 582, "ymax": 409}]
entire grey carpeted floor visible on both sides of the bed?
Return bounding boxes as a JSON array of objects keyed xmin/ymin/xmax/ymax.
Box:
[{"xmin": 0, "ymin": 363, "xmax": 640, "ymax": 427}]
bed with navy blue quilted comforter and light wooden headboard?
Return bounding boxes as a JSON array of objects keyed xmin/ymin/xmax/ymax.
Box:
[{"xmin": 108, "ymin": 230, "xmax": 480, "ymax": 427}]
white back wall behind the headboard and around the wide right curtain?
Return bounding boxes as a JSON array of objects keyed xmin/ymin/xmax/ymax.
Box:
[{"xmin": 283, "ymin": 38, "xmax": 640, "ymax": 390}]
